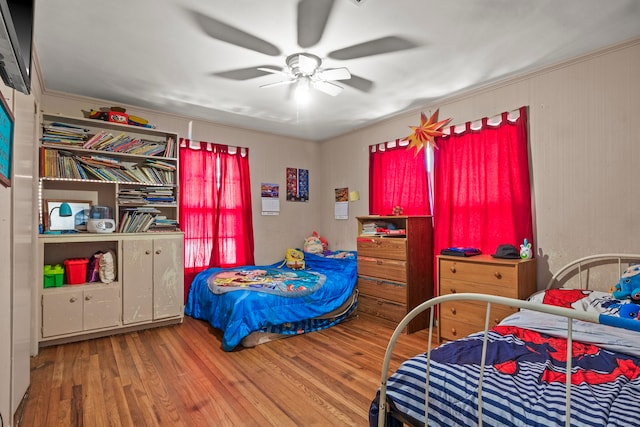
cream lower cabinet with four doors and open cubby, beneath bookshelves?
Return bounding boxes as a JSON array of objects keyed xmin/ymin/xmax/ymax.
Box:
[{"xmin": 37, "ymin": 232, "xmax": 184, "ymax": 345}]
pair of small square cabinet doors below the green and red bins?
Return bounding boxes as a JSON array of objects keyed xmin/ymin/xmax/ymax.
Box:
[{"xmin": 42, "ymin": 284, "xmax": 121, "ymax": 338}]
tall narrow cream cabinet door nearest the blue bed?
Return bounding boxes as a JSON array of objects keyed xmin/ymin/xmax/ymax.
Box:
[{"xmin": 153, "ymin": 236, "xmax": 184, "ymax": 319}]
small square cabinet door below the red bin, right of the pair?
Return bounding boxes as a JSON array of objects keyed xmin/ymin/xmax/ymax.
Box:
[{"xmin": 83, "ymin": 286, "xmax": 120, "ymax": 331}]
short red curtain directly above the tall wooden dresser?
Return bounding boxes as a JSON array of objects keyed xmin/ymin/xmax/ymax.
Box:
[{"xmin": 369, "ymin": 140, "xmax": 431, "ymax": 215}]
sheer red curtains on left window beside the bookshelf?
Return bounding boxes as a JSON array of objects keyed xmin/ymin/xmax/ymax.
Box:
[{"xmin": 180, "ymin": 138, "xmax": 254, "ymax": 301}]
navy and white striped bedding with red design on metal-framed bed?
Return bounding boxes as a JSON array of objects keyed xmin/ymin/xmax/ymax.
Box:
[{"xmin": 370, "ymin": 295, "xmax": 640, "ymax": 426}]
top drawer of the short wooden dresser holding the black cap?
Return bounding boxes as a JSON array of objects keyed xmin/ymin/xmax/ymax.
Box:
[{"xmin": 439, "ymin": 259, "xmax": 517, "ymax": 285}]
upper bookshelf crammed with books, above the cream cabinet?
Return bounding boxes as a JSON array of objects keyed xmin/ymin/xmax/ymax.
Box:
[{"xmin": 39, "ymin": 114, "xmax": 179, "ymax": 232}]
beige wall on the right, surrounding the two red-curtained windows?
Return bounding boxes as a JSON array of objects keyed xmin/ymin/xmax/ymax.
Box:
[{"xmin": 322, "ymin": 39, "xmax": 640, "ymax": 287}]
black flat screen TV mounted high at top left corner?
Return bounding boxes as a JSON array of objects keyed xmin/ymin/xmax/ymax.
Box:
[{"xmin": 0, "ymin": 0, "xmax": 35, "ymax": 94}]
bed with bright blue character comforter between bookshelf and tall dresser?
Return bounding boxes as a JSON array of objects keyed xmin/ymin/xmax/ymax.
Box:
[{"xmin": 185, "ymin": 251, "xmax": 357, "ymax": 351}]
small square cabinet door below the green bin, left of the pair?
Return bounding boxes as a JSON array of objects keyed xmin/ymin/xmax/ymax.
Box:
[{"xmin": 42, "ymin": 289, "xmax": 82, "ymax": 337}]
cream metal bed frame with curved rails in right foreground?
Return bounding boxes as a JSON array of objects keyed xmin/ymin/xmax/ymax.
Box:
[{"xmin": 378, "ymin": 253, "xmax": 640, "ymax": 427}]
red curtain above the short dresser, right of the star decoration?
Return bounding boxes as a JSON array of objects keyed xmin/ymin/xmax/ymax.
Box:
[{"xmin": 433, "ymin": 107, "xmax": 535, "ymax": 260}]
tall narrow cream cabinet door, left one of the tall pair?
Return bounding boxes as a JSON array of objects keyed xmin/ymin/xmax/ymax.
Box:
[{"xmin": 122, "ymin": 239, "xmax": 153, "ymax": 325}]
